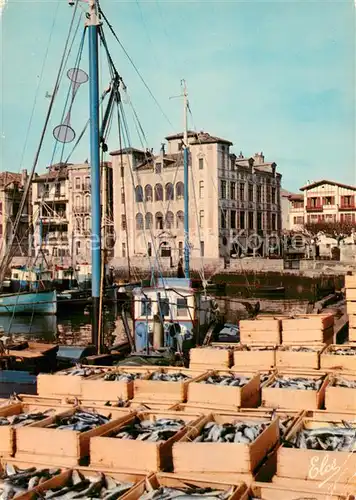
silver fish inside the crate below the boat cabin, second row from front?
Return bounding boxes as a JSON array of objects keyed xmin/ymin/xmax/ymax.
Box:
[{"xmin": 113, "ymin": 418, "xmax": 186, "ymax": 443}]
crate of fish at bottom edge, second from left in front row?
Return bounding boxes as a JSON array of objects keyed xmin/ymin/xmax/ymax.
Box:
[{"xmin": 16, "ymin": 469, "xmax": 145, "ymax": 500}]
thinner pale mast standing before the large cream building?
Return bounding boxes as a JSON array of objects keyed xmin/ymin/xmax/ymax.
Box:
[{"xmin": 182, "ymin": 80, "xmax": 189, "ymax": 278}]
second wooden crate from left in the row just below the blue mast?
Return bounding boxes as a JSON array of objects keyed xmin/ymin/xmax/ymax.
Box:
[{"xmin": 81, "ymin": 367, "xmax": 149, "ymax": 401}]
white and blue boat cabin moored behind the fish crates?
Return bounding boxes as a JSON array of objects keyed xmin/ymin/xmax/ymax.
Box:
[{"xmin": 133, "ymin": 278, "xmax": 216, "ymax": 351}]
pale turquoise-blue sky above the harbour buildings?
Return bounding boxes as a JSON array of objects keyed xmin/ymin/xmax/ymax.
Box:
[{"xmin": 0, "ymin": 0, "xmax": 356, "ymax": 190}]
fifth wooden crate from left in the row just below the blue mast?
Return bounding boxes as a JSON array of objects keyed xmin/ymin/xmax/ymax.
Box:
[{"xmin": 262, "ymin": 371, "xmax": 329, "ymax": 410}]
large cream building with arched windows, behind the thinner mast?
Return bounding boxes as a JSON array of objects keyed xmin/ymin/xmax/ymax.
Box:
[{"xmin": 111, "ymin": 132, "xmax": 281, "ymax": 264}]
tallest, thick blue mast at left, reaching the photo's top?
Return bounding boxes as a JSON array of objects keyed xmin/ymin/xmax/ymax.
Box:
[{"xmin": 87, "ymin": 0, "xmax": 101, "ymax": 346}]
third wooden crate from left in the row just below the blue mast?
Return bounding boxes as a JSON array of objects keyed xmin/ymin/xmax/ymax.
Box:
[{"xmin": 134, "ymin": 366, "xmax": 204, "ymax": 403}]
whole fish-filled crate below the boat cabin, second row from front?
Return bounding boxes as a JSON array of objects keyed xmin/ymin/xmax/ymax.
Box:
[{"xmin": 90, "ymin": 412, "xmax": 202, "ymax": 472}]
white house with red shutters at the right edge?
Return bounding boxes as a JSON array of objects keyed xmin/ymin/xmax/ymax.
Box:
[{"xmin": 290, "ymin": 180, "xmax": 356, "ymax": 230}]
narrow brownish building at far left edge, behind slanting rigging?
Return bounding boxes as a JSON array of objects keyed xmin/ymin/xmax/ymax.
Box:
[{"xmin": 0, "ymin": 170, "xmax": 30, "ymax": 258}]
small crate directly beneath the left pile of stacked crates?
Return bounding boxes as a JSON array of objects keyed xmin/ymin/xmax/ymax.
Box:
[{"xmin": 232, "ymin": 344, "xmax": 276, "ymax": 370}]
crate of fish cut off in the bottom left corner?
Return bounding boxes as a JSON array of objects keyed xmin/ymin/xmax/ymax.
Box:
[{"xmin": 0, "ymin": 462, "xmax": 62, "ymax": 500}]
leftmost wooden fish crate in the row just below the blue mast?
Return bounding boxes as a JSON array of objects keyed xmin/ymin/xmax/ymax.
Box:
[{"xmin": 37, "ymin": 366, "xmax": 112, "ymax": 397}]
